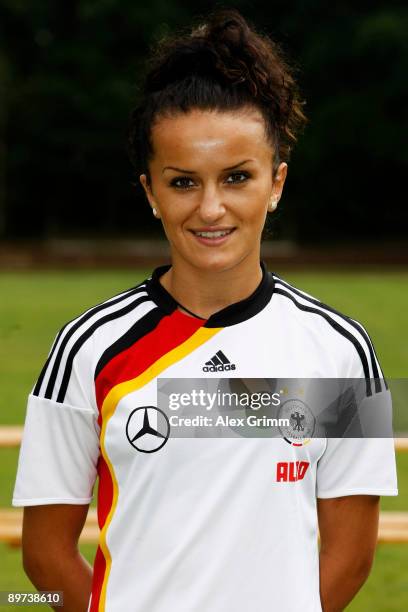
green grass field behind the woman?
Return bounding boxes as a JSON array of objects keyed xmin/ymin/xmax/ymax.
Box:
[{"xmin": 0, "ymin": 266, "xmax": 408, "ymax": 612}]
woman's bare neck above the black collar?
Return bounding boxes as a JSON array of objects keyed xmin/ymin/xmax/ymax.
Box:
[{"xmin": 160, "ymin": 253, "xmax": 262, "ymax": 319}]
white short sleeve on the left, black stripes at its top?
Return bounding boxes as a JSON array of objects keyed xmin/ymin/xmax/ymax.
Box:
[{"xmin": 12, "ymin": 321, "xmax": 100, "ymax": 506}]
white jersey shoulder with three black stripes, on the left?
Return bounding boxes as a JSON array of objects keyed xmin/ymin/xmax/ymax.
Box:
[{"xmin": 32, "ymin": 277, "xmax": 154, "ymax": 403}]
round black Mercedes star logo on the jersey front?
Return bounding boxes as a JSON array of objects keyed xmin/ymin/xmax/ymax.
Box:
[{"xmin": 126, "ymin": 406, "xmax": 170, "ymax": 453}]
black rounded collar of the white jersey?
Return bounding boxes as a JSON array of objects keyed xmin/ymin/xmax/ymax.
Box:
[{"xmin": 146, "ymin": 260, "xmax": 274, "ymax": 327}]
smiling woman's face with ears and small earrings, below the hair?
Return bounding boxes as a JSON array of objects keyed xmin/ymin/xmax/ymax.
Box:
[{"xmin": 140, "ymin": 108, "xmax": 287, "ymax": 270}]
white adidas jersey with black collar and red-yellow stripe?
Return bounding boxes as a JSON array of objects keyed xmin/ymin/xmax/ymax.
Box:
[{"xmin": 13, "ymin": 261, "xmax": 398, "ymax": 612}]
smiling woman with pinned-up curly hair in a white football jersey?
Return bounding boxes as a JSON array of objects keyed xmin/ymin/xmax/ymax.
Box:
[{"xmin": 13, "ymin": 10, "xmax": 397, "ymax": 612}]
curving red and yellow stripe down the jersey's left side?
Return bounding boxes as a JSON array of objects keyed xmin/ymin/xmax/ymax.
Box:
[{"xmin": 90, "ymin": 310, "xmax": 223, "ymax": 612}]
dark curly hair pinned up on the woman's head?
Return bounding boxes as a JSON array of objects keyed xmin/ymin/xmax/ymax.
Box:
[{"xmin": 128, "ymin": 9, "xmax": 306, "ymax": 186}]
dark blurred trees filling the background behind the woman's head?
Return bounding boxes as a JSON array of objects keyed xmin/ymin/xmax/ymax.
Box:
[{"xmin": 0, "ymin": 0, "xmax": 408, "ymax": 243}]
